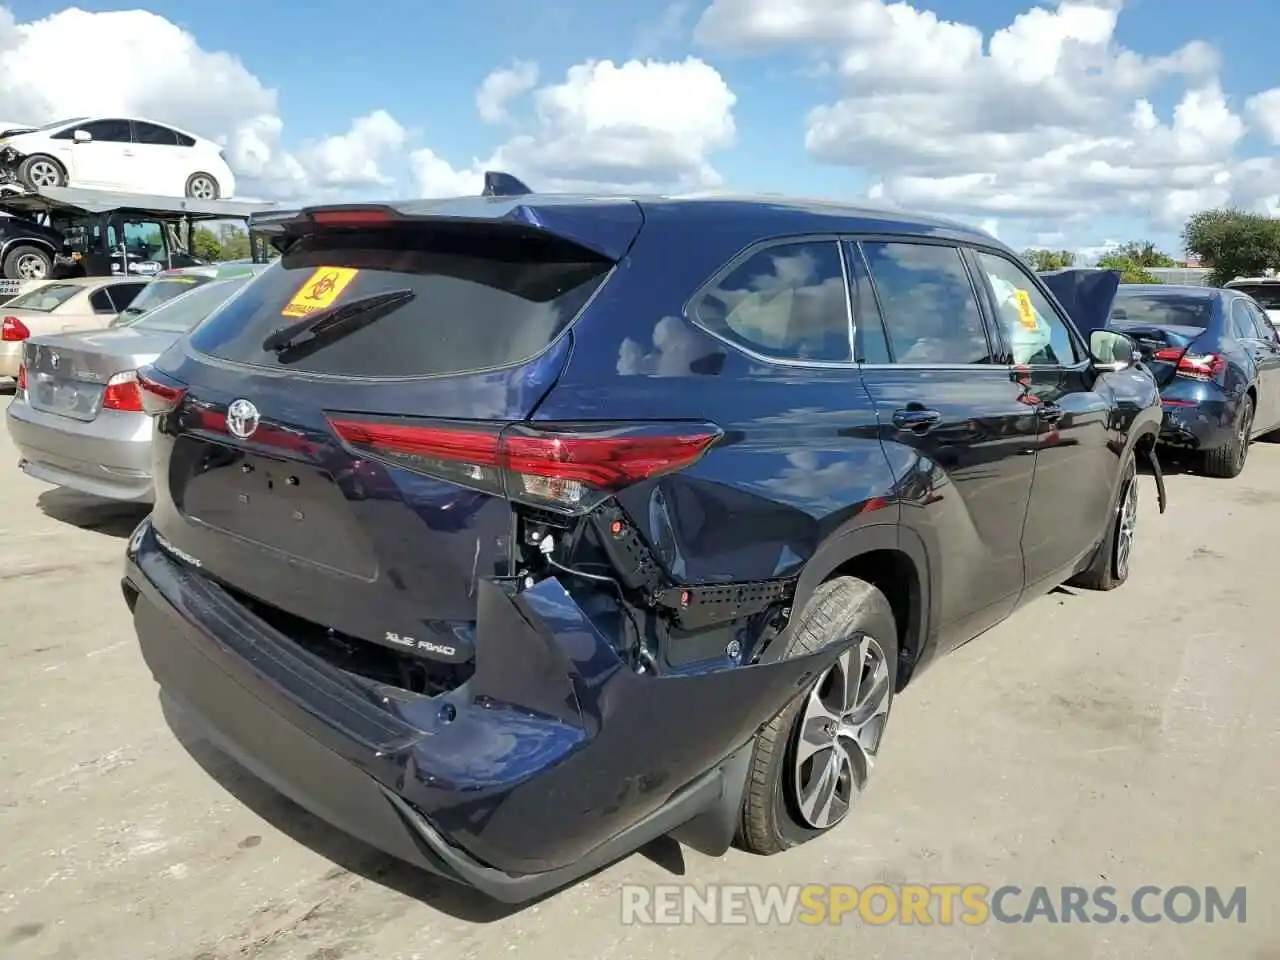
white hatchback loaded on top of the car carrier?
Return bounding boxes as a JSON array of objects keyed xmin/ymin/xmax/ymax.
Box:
[{"xmin": 0, "ymin": 116, "xmax": 236, "ymax": 200}]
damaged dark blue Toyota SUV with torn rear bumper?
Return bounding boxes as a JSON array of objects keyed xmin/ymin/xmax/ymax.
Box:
[{"xmin": 123, "ymin": 188, "xmax": 1164, "ymax": 901}]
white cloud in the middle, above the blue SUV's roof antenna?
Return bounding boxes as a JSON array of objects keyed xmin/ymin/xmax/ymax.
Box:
[{"xmin": 412, "ymin": 58, "xmax": 737, "ymax": 196}]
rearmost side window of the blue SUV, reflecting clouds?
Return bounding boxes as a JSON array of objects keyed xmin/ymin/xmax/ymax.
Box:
[{"xmin": 694, "ymin": 241, "xmax": 850, "ymax": 361}]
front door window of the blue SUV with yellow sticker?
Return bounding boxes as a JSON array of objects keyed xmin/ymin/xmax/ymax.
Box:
[{"xmin": 978, "ymin": 252, "xmax": 1084, "ymax": 366}]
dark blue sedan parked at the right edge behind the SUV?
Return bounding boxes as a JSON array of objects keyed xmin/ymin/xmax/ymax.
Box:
[{"xmin": 1111, "ymin": 284, "xmax": 1280, "ymax": 477}]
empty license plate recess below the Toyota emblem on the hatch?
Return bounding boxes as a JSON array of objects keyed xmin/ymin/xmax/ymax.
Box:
[{"xmin": 170, "ymin": 438, "xmax": 378, "ymax": 580}]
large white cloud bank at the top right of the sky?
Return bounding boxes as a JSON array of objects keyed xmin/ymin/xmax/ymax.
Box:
[{"xmin": 696, "ymin": 0, "xmax": 1280, "ymax": 239}]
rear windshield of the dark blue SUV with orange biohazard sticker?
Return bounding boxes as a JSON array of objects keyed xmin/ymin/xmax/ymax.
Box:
[{"xmin": 191, "ymin": 227, "xmax": 612, "ymax": 378}]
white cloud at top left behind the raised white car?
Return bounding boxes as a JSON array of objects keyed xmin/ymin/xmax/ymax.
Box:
[{"xmin": 0, "ymin": 6, "xmax": 407, "ymax": 198}]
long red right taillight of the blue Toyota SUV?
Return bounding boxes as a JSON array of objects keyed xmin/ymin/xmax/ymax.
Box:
[{"xmin": 329, "ymin": 416, "xmax": 721, "ymax": 513}]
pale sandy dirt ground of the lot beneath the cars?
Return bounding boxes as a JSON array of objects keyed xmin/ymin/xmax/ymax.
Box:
[{"xmin": 0, "ymin": 419, "xmax": 1280, "ymax": 960}]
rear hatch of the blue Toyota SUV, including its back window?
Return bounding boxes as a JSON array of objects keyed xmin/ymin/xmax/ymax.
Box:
[{"xmin": 145, "ymin": 207, "xmax": 639, "ymax": 663}]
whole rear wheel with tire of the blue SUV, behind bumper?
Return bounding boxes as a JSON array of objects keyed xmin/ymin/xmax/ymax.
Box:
[{"xmin": 737, "ymin": 577, "xmax": 897, "ymax": 855}]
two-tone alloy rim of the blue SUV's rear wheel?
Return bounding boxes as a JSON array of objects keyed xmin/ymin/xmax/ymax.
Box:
[{"xmin": 792, "ymin": 634, "xmax": 891, "ymax": 829}]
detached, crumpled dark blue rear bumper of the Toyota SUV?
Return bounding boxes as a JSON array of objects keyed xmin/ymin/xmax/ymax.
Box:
[{"xmin": 123, "ymin": 520, "xmax": 844, "ymax": 902}]
